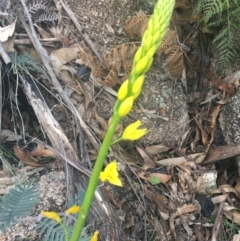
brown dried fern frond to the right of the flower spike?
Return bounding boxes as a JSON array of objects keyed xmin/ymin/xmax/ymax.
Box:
[{"xmin": 163, "ymin": 44, "xmax": 184, "ymax": 78}]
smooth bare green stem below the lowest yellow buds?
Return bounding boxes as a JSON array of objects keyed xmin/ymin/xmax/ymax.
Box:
[{"xmin": 70, "ymin": 114, "xmax": 120, "ymax": 241}]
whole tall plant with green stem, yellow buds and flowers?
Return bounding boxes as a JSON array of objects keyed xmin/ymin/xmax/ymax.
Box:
[{"xmin": 42, "ymin": 0, "xmax": 175, "ymax": 241}]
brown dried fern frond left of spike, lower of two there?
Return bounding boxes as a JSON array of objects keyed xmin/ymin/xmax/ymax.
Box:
[{"xmin": 102, "ymin": 43, "xmax": 137, "ymax": 75}]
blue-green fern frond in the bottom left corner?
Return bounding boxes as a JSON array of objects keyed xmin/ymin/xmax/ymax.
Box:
[{"xmin": 0, "ymin": 181, "xmax": 38, "ymax": 232}]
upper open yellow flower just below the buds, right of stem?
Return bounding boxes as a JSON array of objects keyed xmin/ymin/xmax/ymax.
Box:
[{"xmin": 121, "ymin": 120, "xmax": 147, "ymax": 141}]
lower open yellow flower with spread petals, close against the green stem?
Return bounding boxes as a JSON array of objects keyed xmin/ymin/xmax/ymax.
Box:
[{"xmin": 100, "ymin": 161, "xmax": 122, "ymax": 187}]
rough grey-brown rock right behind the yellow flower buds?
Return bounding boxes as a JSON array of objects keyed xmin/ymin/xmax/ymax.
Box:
[{"xmin": 134, "ymin": 70, "xmax": 189, "ymax": 145}]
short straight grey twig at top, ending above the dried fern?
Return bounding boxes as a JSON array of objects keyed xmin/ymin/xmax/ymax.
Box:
[{"xmin": 60, "ymin": 0, "xmax": 102, "ymax": 61}]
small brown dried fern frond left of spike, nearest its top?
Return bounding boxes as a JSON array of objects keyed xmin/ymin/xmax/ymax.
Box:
[{"xmin": 124, "ymin": 14, "xmax": 150, "ymax": 38}]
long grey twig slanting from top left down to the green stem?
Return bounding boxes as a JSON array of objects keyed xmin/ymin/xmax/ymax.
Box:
[{"xmin": 19, "ymin": 0, "xmax": 99, "ymax": 150}]
